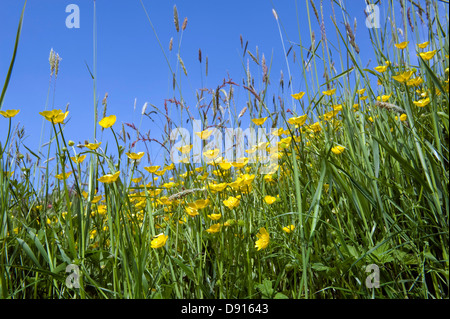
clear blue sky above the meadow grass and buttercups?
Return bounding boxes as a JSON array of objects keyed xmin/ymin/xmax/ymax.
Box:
[{"xmin": 0, "ymin": 0, "xmax": 428, "ymax": 170}]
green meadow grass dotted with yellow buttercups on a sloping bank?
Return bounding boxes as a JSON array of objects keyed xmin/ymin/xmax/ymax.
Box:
[{"xmin": 0, "ymin": 0, "xmax": 449, "ymax": 299}]
